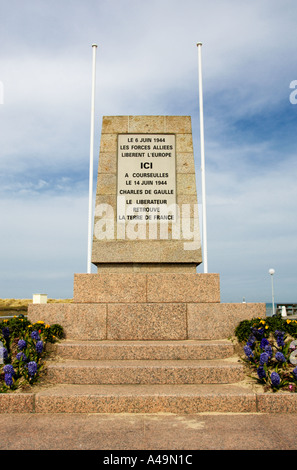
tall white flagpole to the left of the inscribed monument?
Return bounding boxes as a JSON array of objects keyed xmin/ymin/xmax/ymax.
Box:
[{"xmin": 87, "ymin": 44, "xmax": 97, "ymax": 274}]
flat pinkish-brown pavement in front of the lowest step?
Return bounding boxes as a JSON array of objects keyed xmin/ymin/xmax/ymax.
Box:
[{"xmin": 0, "ymin": 413, "xmax": 297, "ymax": 452}]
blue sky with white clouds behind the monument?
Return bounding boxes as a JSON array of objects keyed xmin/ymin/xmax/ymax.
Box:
[{"xmin": 0, "ymin": 0, "xmax": 297, "ymax": 303}]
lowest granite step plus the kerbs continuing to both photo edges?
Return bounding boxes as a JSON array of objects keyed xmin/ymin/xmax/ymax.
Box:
[{"xmin": 0, "ymin": 382, "xmax": 297, "ymax": 414}]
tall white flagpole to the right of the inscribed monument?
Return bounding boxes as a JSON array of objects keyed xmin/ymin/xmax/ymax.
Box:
[{"xmin": 197, "ymin": 42, "xmax": 208, "ymax": 273}]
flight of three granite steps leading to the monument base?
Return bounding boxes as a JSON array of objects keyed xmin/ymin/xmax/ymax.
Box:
[{"xmin": 28, "ymin": 340, "xmax": 254, "ymax": 413}]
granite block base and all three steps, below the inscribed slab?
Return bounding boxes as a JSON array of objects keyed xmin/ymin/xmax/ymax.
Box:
[{"xmin": 17, "ymin": 272, "xmax": 284, "ymax": 414}]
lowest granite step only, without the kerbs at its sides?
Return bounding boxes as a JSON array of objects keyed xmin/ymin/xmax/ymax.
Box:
[{"xmin": 33, "ymin": 384, "xmax": 258, "ymax": 414}]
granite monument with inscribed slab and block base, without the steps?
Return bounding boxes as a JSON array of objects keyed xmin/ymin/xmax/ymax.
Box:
[{"xmin": 29, "ymin": 116, "xmax": 265, "ymax": 340}]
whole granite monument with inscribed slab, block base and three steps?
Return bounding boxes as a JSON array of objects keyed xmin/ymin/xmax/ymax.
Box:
[{"xmin": 24, "ymin": 116, "xmax": 265, "ymax": 413}]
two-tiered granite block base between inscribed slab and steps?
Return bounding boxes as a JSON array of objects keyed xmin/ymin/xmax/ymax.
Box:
[{"xmin": 28, "ymin": 272, "xmax": 266, "ymax": 341}]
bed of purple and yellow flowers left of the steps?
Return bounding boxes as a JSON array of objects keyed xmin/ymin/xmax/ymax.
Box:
[{"xmin": 0, "ymin": 315, "xmax": 63, "ymax": 393}]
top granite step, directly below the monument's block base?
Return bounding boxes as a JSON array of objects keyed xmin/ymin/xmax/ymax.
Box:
[{"xmin": 50, "ymin": 340, "xmax": 234, "ymax": 361}]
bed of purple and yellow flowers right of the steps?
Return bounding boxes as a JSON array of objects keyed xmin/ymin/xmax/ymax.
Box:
[{"xmin": 235, "ymin": 317, "xmax": 297, "ymax": 392}]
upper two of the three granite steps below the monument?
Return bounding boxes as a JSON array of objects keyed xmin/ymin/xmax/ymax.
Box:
[{"xmin": 47, "ymin": 341, "xmax": 243, "ymax": 385}]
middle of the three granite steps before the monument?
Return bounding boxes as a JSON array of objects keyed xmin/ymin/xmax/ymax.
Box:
[{"xmin": 46, "ymin": 359, "xmax": 244, "ymax": 385}]
